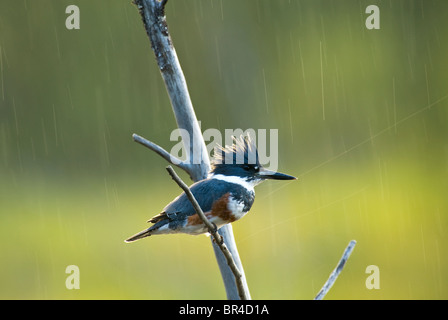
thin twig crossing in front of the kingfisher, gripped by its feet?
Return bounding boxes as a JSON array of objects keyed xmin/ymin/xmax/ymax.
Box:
[{"xmin": 166, "ymin": 166, "xmax": 248, "ymax": 300}]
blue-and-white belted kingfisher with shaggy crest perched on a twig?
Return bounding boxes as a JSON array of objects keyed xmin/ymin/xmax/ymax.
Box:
[{"xmin": 125, "ymin": 136, "xmax": 297, "ymax": 242}]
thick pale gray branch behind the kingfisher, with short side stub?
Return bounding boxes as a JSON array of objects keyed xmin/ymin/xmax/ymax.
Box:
[{"xmin": 133, "ymin": 0, "xmax": 250, "ymax": 300}]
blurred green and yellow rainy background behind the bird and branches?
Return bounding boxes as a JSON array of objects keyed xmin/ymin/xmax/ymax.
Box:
[{"xmin": 0, "ymin": 0, "xmax": 448, "ymax": 299}]
